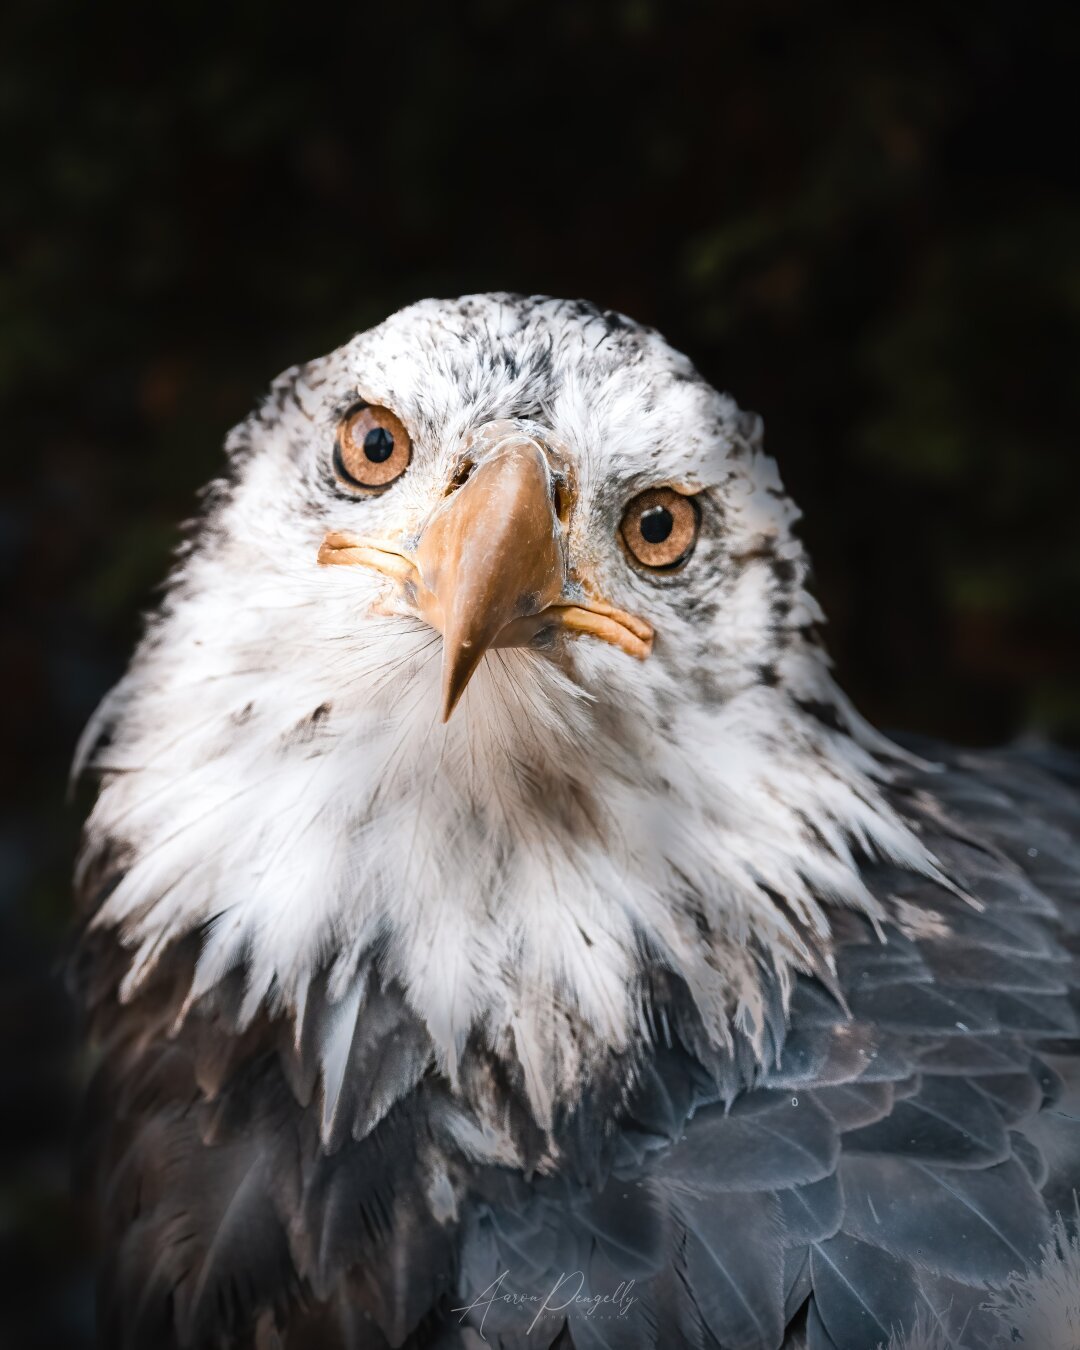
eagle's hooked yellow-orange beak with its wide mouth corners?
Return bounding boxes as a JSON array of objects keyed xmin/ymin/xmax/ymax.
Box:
[{"xmin": 311, "ymin": 423, "xmax": 652, "ymax": 721}]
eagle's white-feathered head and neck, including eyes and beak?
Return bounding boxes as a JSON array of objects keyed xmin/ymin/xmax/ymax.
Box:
[{"xmin": 84, "ymin": 294, "xmax": 933, "ymax": 1125}]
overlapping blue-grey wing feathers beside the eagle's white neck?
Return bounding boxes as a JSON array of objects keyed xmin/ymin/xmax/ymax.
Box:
[{"xmin": 459, "ymin": 752, "xmax": 1080, "ymax": 1350}]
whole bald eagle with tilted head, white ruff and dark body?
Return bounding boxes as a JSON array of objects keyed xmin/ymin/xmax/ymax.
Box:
[{"xmin": 74, "ymin": 294, "xmax": 1080, "ymax": 1350}]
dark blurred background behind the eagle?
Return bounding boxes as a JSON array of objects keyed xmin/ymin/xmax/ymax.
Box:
[{"xmin": 0, "ymin": 0, "xmax": 1080, "ymax": 1347}]
